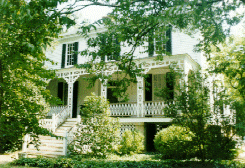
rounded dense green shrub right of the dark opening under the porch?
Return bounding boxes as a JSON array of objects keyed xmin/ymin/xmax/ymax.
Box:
[{"xmin": 154, "ymin": 126, "xmax": 194, "ymax": 159}]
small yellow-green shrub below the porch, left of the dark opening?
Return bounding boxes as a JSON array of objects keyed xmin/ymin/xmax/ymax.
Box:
[{"xmin": 119, "ymin": 130, "xmax": 144, "ymax": 154}]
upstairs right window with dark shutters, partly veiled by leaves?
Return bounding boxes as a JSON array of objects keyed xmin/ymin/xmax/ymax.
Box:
[{"xmin": 148, "ymin": 27, "xmax": 172, "ymax": 57}]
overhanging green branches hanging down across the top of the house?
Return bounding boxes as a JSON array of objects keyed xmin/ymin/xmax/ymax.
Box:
[{"xmin": 73, "ymin": 0, "xmax": 244, "ymax": 98}]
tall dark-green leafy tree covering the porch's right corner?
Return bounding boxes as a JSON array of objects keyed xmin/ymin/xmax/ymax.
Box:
[{"xmin": 162, "ymin": 73, "xmax": 236, "ymax": 161}]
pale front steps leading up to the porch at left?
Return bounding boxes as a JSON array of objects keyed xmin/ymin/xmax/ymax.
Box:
[{"xmin": 20, "ymin": 118, "xmax": 77, "ymax": 157}]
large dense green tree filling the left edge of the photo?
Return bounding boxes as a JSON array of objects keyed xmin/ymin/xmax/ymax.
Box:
[{"xmin": 0, "ymin": 0, "xmax": 74, "ymax": 153}]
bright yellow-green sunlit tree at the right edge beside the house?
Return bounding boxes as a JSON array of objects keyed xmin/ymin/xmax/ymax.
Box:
[{"xmin": 210, "ymin": 37, "xmax": 245, "ymax": 136}]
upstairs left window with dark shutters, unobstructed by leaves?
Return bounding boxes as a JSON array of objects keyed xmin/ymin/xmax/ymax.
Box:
[{"xmin": 61, "ymin": 42, "xmax": 78, "ymax": 68}]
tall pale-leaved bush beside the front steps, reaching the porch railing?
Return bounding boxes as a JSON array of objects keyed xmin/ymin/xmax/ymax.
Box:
[{"xmin": 69, "ymin": 95, "xmax": 119, "ymax": 158}]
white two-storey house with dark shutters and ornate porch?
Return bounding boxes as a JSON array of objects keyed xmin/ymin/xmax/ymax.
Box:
[{"xmin": 23, "ymin": 25, "xmax": 209, "ymax": 154}]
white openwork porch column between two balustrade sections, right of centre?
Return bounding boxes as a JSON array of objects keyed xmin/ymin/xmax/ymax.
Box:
[{"xmin": 136, "ymin": 76, "xmax": 144, "ymax": 117}]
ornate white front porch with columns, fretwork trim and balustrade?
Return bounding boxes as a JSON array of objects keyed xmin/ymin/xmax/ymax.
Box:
[{"xmin": 48, "ymin": 54, "xmax": 199, "ymax": 118}]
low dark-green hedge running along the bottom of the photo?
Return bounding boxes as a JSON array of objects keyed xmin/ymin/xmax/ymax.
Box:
[{"xmin": 11, "ymin": 158, "xmax": 245, "ymax": 168}]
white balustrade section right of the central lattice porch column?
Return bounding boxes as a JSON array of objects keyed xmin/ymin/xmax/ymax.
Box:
[{"xmin": 143, "ymin": 101, "xmax": 165, "ymax": 116}]
